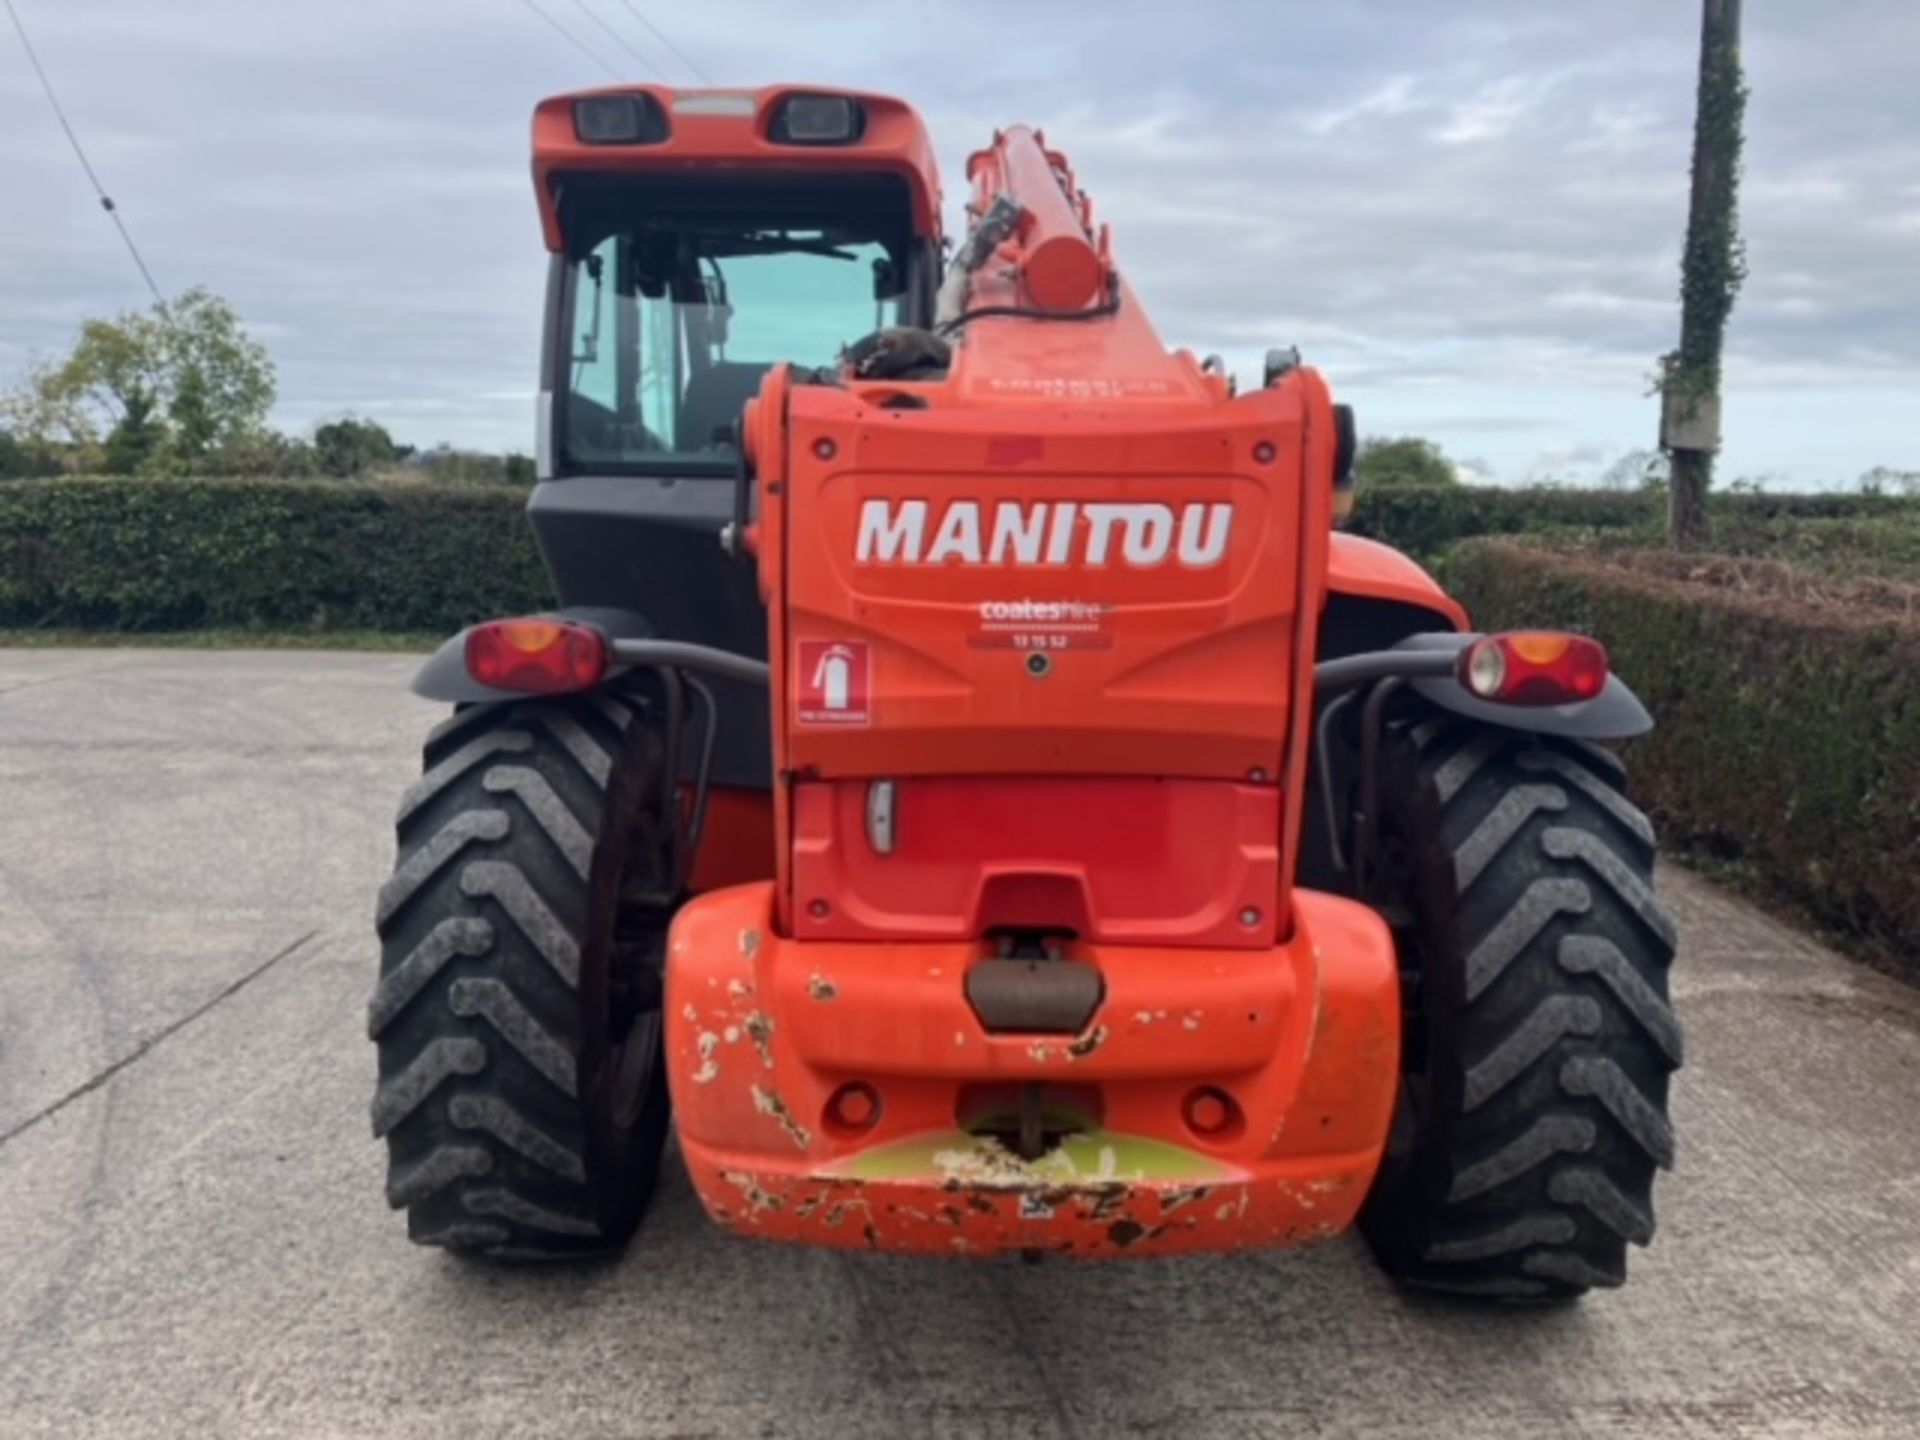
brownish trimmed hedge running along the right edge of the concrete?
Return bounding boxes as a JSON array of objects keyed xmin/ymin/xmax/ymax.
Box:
[{"xmin": 1450, "ymin": 541, "xmax": 1920, "ymax": 979}]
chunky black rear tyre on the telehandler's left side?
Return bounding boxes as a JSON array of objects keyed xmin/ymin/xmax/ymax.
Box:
[{"xmin": 367, "ymin": 693, "xmax": 668, "ymax": 1260}]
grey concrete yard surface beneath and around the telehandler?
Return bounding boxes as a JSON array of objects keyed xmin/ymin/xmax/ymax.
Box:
[{"xmin": 0, "ymin": 651, "xmax": 1920, "ymax": 1438}]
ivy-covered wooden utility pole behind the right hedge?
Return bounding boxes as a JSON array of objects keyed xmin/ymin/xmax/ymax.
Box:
[{"xmin": 1659, "ymin": 0, "xmax": 1747, "ymax": 549}]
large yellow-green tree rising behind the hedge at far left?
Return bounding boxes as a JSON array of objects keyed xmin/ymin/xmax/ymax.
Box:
[{"xmin": 0, "ymin": 286, "xmax": 275, "ymax": 472}]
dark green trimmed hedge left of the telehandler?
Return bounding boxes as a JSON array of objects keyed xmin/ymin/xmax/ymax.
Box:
[{"xmin": 0, "ymin": 480, "xmax": 553, "ymax": 632}]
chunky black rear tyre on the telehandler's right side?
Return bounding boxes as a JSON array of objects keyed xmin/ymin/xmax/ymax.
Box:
[{"xmin": 1359, "ymin": 718, "xmax": 1680, "ymax": 1304}]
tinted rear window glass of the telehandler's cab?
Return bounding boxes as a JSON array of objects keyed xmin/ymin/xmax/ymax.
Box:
[{"xmin": 561, "ymin": 186, "xmax": 906, "ymax": 474}]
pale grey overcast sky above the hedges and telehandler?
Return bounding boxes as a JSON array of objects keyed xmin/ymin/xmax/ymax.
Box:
[{"xmin": 0, "ymin": 0, "xmax": 1920, "ymax": 486}]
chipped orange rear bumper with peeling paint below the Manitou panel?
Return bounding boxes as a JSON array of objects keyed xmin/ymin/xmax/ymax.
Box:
[{"xmin": 666, "ymin": 883, "xmax": 1400, "ymax": 1256}]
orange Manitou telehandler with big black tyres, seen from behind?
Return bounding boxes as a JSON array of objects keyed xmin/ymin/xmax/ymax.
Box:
[{"xmin": 369, "ymin": 86, "xmax": 1680, "ymax": 1300}]
